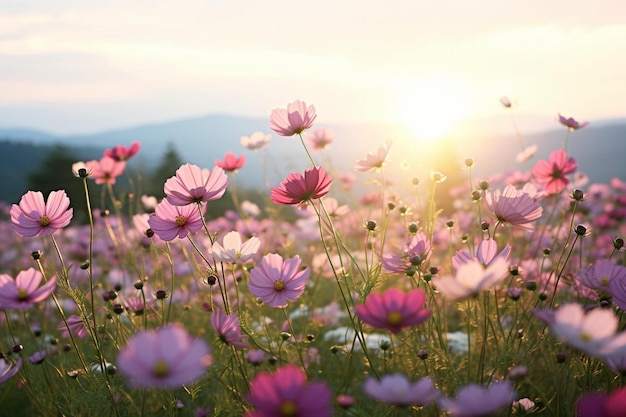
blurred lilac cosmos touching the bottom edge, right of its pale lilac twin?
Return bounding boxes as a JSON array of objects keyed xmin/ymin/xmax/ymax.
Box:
[{"xmin": 439, "ymin": 380, "xmax": 517, "ymax": 417}]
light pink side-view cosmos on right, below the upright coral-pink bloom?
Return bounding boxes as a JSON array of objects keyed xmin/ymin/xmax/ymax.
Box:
[{"xmin": 485, "ymin": 185, "xmax": 543, "ymax": 231}]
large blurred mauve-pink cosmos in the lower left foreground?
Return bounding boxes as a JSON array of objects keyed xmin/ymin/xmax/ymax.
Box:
[{"xmin": 117, "ymin": 325, "xmax": 212, "ymax": 388}]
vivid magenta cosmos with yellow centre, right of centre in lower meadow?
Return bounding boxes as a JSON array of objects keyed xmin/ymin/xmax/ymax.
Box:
[{"xmin": 356, "ymin": 288, "xmax": 432, "ymax": 333}]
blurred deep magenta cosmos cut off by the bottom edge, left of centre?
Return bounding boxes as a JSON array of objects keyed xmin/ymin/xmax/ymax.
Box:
[{"xmin": 246, "ymin": 365, "xmax": 332, "ymax": 417}]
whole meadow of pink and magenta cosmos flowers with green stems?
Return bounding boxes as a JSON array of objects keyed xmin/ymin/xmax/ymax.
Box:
[{"xmin": 0, "ymin": 98, "xmax": 626, "ymax": 417}]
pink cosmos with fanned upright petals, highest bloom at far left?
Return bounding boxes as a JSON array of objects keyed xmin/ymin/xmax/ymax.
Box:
[{"xmin": 10, "ymin": 190, "xmax": 74, "ymax": 237}]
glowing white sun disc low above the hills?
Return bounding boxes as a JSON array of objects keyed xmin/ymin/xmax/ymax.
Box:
[{"xmin": 395, "ymin": 77, "xmax": 468, "ymax": 142}]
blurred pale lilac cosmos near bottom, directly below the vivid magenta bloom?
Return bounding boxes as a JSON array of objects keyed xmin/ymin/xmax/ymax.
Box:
[{"xmin": 363, "ymin": 374, "xmax": 440, "ymax": 406}]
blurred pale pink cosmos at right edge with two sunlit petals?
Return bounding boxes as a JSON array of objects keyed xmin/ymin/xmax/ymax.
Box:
[{"xmin": 550, "ymin": 303, "xmax": 626, "ymax": 356}]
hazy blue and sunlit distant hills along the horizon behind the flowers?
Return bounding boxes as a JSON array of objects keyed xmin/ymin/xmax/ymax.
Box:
[{"xmin": 0, "ymin": 114, "xmax": 626, "ymax": 205}]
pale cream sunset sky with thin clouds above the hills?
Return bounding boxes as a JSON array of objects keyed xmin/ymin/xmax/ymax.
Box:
[{"xmin": 0, "ymin": 0, "xmax": 626, "ymax": 138}]
